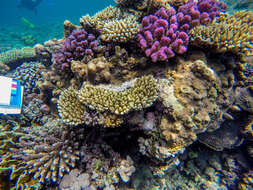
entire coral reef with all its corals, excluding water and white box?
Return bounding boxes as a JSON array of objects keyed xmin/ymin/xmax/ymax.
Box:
[{"xmin": 0, "ymin": 0, "xmax": 253, "ymax": 190}]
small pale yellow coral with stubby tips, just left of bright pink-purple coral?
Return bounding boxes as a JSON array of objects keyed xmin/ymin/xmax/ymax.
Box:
[{"xmin": 101, "ymin": 15, "xmax": 140, "ymax": 42}]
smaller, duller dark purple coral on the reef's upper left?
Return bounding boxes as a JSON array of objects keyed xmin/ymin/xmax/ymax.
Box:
[{"xmin": 54, "ymin": 29, "xmax": 98, "ymax": 71}]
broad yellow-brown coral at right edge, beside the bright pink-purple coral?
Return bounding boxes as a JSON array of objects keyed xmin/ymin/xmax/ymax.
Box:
[{"xmin": 190, "ymin": 11, "xmax": 253, "ymax": 56}]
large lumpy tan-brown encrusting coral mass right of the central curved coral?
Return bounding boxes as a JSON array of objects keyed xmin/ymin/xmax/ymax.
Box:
[{"xmin": 139, "ymin": 57, "xmax": 234, "ymax": 161}]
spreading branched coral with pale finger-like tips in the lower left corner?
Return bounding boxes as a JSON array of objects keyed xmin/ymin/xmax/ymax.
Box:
[{"xmin": 0, "ymin": 120, "xmax": 83, "ymax": 189}]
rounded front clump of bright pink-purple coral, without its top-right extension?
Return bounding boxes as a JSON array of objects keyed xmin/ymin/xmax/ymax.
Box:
[{"xmin": 138, "ymin": 8, "xmax": 189, "ymax": 62}]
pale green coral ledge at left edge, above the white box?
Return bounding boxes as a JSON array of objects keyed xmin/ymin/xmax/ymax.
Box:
[{"xmin": 0, "ymin": 47, "xmax": 36, "ymax": 73}]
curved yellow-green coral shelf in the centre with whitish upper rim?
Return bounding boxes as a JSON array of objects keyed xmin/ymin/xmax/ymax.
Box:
[{"xmin": 78, "ymin": 75, "xmax": 158, "ymax": 115}]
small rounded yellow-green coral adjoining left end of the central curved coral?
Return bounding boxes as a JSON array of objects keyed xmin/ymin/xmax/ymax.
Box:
[{"xmin": 57, "ymin": 88, "xmax": 86, "ymax": 125}]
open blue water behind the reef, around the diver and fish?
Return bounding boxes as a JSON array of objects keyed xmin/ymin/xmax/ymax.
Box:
[{"xmin": 0, "ymin": 0, "xmax": 115, "ymax": 49}]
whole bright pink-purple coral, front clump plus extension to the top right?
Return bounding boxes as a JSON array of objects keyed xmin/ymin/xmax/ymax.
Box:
[{"xmin": 138, "ymin": 0, "xmax": 225, "ymax": 62}]
